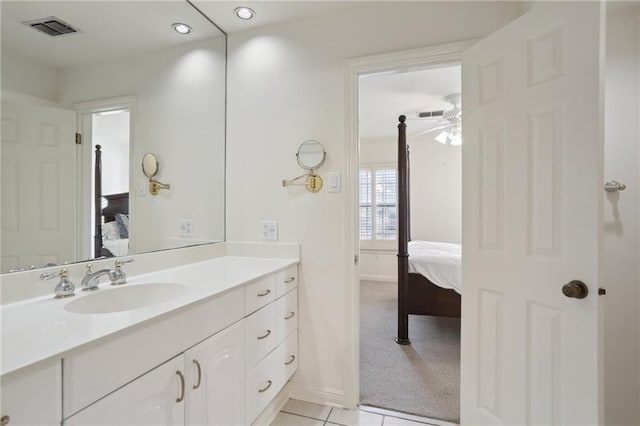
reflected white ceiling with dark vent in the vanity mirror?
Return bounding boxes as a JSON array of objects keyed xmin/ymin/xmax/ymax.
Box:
[{"xmin": 0, "ymin": 0, "xmax": 220, "ymax": 68}]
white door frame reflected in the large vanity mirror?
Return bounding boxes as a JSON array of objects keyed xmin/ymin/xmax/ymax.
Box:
[{"xmin": 71, "ymin": 96, "xmax": 136, "ymax": 259}]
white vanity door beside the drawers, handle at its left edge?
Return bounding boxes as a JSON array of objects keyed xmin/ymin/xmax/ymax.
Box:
[{"xmin": 185, "ymin": 320, "xmax": 246, "ymax": 426}]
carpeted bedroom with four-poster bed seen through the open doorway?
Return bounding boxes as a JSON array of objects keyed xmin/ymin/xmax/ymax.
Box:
[{"xmin": 358, "ymin": 64, "xmax": 462, "ymax": 423}]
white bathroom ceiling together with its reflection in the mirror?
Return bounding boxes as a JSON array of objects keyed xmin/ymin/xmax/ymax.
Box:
[{"xmin": 0, "ymin": 0, "xmax": 354, "ymax": 68}]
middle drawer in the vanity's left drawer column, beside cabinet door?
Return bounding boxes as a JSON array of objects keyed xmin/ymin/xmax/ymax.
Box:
[{"xmin": 246, "ymin": 303, "xmax": 276, "ymax": 370}]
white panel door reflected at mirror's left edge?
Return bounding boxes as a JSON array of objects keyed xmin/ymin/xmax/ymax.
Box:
[{"xmin": 0, "ymin": 100, "xmax": 76, "ymax": 272}]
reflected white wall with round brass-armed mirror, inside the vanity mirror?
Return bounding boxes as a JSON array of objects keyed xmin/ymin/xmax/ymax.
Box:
[{"xmin": 60, "ymin": 37, "xmax": 225, "ymax": 253}]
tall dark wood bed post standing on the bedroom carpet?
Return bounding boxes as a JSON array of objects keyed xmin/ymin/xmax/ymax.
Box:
[{"xmin": 396, "ymin": 115, "xmax": 411, "ymax": 345}]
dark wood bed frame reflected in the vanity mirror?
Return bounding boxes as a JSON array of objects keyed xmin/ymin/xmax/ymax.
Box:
[{"xmin": 93, "ymin": 145, "xmax": 129, "ymax": 259}]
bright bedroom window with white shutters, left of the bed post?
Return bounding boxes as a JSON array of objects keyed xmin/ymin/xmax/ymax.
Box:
[{"xmin": 360, "ymin": 165, "xmax": 398, "ymax": 248}]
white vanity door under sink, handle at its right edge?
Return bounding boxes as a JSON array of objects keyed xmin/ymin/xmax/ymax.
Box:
[{"xmin": 63, "ymin": 356, "xmax": 187, "ymax": 426}]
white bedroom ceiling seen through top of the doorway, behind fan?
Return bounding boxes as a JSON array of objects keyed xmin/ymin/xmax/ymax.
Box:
[{"xmin": 358, "ymin": 65, "xmax": 462, "ymax": 142}]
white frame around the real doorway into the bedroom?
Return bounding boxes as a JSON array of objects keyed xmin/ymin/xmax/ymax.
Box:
[{"xmin": 343, "ymin": 39, "xmax": 478, "ymax": 408}]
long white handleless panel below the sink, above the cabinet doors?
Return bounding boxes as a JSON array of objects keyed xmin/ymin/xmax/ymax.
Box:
[{"xmin": 62, "ymin": 288, "xmax": 244, "ymax": 418}]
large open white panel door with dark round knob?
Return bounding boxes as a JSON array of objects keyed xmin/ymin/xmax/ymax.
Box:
[{"xmin": 461, "ymin": 2, "xmax": 604, "ymax": 425}]
